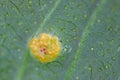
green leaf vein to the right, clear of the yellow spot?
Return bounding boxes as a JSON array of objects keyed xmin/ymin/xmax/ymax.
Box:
[{"xmin": 65, "ymin": 0, "xmax": 106, "ymax": 80}]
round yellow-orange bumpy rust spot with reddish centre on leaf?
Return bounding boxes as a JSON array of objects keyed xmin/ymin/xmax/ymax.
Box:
[{"xmin": 29, "ymin": 33, "xmax": 61, "ymax": 62}]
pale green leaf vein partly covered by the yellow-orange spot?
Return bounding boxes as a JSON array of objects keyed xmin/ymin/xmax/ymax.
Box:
[{"xmin": 15, "ymin": 0, "xmax": 61, "ymax": 80}]
